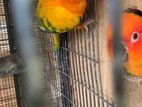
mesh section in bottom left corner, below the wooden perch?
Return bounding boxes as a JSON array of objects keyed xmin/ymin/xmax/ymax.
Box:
[{"xmin": 0, "ymin": 76, "xmax": 17, "ymax": 107}]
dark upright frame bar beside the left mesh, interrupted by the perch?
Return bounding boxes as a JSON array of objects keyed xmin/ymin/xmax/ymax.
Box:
[{"xmin": 3, "ymin": 0, "xmax": 22, "ymax": 107}]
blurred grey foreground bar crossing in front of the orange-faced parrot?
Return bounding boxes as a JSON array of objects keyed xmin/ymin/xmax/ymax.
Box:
[{"xmin": 108, "ymin": 0, "xmax": 126, "ymax": 107}]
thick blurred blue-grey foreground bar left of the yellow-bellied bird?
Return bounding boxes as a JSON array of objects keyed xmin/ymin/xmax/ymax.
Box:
[{"xmin": 12, "ymin": 0, "xmax": 44, "ymax": 107}]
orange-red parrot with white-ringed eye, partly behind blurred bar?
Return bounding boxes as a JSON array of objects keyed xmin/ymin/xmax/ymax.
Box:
[{"xmin": 106, "ymin": 8, "xmax": 142, "ymax": 77}]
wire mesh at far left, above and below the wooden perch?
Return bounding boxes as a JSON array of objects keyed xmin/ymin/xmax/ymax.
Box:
[{"xmin": 0, "ymin": 0, "xmax": 17, "ymax": 107}]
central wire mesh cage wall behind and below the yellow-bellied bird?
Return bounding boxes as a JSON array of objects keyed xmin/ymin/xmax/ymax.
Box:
[{"xmin": 35, "ymin": 0, "xmax": 113, "ymax": 107}]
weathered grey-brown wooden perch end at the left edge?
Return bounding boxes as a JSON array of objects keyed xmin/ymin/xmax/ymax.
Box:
[{"xmin": 0, "ymin": 54, "xmax": 24, "ymax": 77}]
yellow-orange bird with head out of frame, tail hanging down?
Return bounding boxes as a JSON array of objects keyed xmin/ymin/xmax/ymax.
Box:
[{"xmin": 36, "ymin": 0, "xmax": 86, "ymax": 50}]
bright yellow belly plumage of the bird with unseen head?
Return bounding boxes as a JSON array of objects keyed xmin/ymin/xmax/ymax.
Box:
[{"xmin": 38, "ymin": 6, "xmax": 80, "ymax": 33}]
